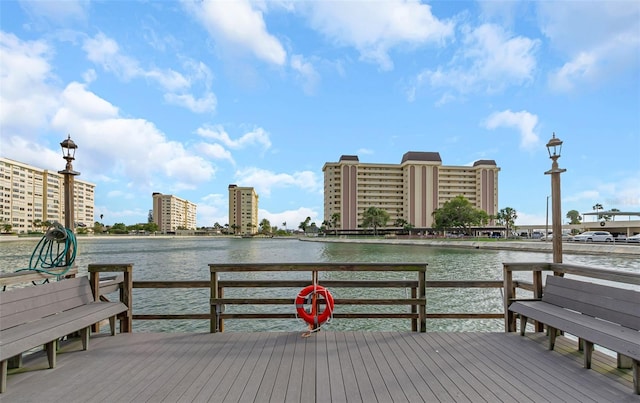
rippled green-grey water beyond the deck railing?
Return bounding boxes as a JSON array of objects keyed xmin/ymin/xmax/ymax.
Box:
[{"xmin": 0, "ymin": 237, "xmax": 640, "ymax": 331}]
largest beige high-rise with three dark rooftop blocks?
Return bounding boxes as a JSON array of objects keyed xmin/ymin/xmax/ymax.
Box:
[{"xmin": 322, "ymin": 151, "xmax": 500, "ymax": 230}]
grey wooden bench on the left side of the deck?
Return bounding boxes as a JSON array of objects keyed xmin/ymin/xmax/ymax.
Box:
[{"xmin": 0, "ymin": 277, "xmax": 128, "ymax": 393}]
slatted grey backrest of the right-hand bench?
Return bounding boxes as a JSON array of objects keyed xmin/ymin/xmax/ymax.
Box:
[{"xmin": 542, "ymin": 276, "xmax": 640, "ymax": 330}]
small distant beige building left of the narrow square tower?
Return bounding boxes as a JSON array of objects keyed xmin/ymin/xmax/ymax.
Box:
[{"xmin": 152, "ymin": 193, "xmax": 198, "ymax": 234}]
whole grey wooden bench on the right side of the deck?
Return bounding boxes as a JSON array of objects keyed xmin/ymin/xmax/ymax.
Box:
[{"xmin": 509, "ymin": 276, "xmax": 640, "ymax": 394}]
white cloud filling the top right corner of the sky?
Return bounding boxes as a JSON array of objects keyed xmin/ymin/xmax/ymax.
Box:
[{"xmin": 537, "ymin": 1, "xmax": 640, "ymax": 91}]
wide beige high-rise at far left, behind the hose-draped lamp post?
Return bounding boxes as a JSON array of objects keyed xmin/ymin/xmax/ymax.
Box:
[{"xmin": 0, "ymin": 157, "xmax": 96, "ymax": 234}]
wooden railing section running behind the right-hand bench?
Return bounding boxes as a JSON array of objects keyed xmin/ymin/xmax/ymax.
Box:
[{"xmin": 503, "ymin": 262, "xmax": 640, "ymax": 332}]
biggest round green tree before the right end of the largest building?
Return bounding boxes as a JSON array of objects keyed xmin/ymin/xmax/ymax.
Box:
[{"xmin": 432, "ymin": 195, "xmax": 489, "ymax": 235}]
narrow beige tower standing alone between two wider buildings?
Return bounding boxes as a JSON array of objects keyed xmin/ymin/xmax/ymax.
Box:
[{"xmin": 229, "ymin": 185, "xmax": 258, "ymax": 234}]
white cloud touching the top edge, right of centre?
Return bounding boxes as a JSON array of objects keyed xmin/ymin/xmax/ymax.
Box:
[{"xmin": 302, "ymin": 0, "xmax": 453, "ymax": 70}]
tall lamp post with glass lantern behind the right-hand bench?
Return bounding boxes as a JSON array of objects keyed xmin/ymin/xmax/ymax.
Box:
[{"xmin": 545, "ymin": 133, "xmax": 567, "ymax": 263}]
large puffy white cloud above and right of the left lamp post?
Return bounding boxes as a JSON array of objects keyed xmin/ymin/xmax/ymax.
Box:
[{"xmin": 43, "ymin": 82, "xmax": 215, "ymax": 189}]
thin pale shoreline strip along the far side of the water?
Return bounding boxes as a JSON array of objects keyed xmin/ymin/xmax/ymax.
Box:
[{"xmin": 0, "ymin": 235, "xmax": 640, "ymax": 257}]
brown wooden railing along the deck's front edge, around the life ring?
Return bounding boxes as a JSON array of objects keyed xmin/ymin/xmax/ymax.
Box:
[{"xmin": 0, "ymin": 263, "xmax": 516, "ymax": 332}]
